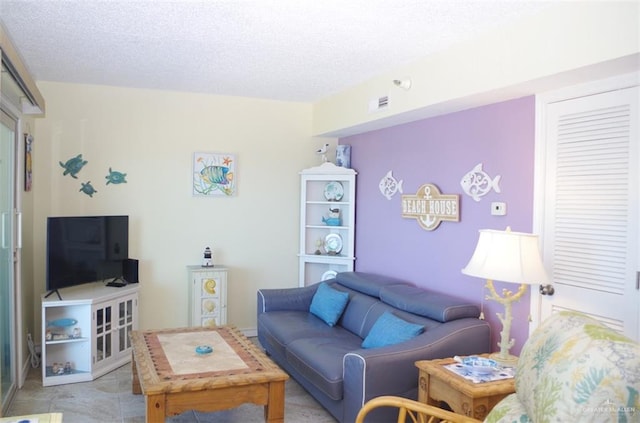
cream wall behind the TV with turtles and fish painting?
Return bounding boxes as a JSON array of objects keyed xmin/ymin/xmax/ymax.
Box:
[{"xmin": 31, "ymin": 82, "xmax": 334, "ymax": 333}]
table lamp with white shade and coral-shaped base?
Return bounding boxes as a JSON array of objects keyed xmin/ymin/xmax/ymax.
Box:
[{"xmin": 462, "ymin": 227, "xmax": 548, "ymax": 366}]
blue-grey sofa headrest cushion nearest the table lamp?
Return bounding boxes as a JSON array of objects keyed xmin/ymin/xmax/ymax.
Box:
[{"xmin": 380, "ymin": 285, "xmax": 480, "ymax": 323}]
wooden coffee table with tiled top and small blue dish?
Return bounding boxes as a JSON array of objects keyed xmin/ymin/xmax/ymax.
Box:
[{"xmin": 131, "ymin": 326, "xmax": 289, "ymax": 423}]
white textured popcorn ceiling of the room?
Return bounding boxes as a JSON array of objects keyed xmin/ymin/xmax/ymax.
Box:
[{"xmin": 0, "ymin": 0, "xmax": 548, "ymax": 102}]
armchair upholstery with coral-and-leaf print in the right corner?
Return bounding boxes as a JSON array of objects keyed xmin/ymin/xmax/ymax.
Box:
[{"xmin": 485, "ymin": 312, "xmax": 640, "ymax": 423}]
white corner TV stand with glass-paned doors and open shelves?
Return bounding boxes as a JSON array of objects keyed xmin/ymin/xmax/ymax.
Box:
[{"xmin": 42, "ymin": 282, "xmax": 139, "ymax": 386}]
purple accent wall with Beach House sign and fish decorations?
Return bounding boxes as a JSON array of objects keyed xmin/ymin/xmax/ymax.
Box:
[{"xmin": 339, "ymin": 97, "xmax": 536, "ymax": 354}]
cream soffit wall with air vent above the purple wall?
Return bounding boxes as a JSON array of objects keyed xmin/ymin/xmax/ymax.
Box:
[{"xmin": 312, "ymin": 1, "xmax": 640, "ymax": 136}]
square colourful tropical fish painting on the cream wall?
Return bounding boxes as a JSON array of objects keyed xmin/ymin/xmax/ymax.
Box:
[{"xmin": 193, "ymin": 153, "xmax": 236, "ymax": 197}]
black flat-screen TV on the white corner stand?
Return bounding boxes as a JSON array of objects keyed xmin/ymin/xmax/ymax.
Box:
[{"xmin": 47, "ymin": 216, "xmax": 129, "ymax": 291}]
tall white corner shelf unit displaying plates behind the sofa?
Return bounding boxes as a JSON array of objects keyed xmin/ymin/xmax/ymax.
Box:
[{"xmin": 298, "ymin": 162, "xmax": 356, "ymax": 286}]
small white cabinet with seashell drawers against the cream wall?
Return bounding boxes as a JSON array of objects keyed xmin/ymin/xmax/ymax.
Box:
[{"xmin": 187, "ymin": 265, "xmax": 228, "ymax": 326}]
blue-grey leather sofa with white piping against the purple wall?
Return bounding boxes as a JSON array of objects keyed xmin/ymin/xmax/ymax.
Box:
[{"xmin": 258, "ymin": 272, "xmax": 490, "ymax": 423}]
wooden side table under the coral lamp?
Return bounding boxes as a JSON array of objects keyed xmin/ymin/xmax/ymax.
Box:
[{"xmin": 416, "ymin": 358, "xmax": 515, "ymax": 420}]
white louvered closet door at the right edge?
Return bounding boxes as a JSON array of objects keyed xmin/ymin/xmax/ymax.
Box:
[{"xmin": 540, "ymin": 87, "xmax": 640, "ymax": 339}]
